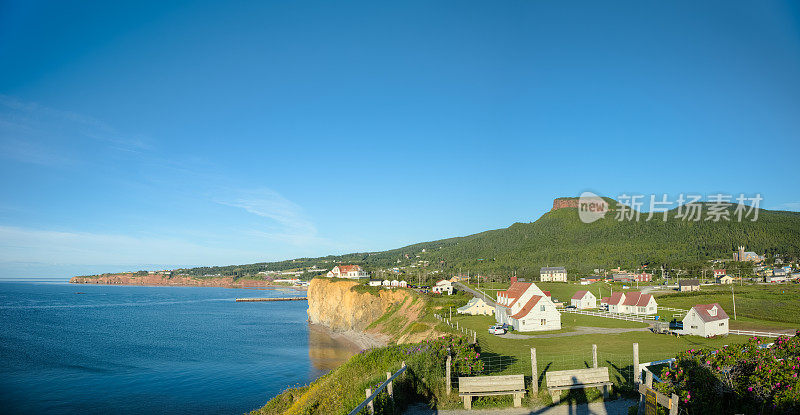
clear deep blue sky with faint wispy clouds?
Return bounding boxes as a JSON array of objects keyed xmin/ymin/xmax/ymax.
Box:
[{"xmin": 0, "ymin": 1, "xmax": 800, "ymax": 277}]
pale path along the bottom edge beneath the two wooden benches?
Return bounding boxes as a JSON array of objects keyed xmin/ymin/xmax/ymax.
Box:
[{"xmin": 405, "ymin": 399, "xmax": 637, "ymax": 415}]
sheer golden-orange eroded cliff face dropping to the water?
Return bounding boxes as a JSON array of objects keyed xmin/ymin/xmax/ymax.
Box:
[{"xmin": 308, "ymin": 278, "xmax": 408, "ymax": 331}]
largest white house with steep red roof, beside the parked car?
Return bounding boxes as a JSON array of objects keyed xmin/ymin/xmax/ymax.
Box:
[{"xmin": 494, "ymin": 282, "xmax": 561, "ymax": 331}]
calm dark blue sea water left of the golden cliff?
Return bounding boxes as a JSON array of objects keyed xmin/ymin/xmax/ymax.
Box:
[{"xmin": 0, "ymin": 282, "xmax": 356, "ymax": 414}]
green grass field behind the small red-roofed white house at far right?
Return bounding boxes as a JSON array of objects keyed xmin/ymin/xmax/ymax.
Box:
[{"xmin": 656, "ymin": 284, "xmax": 800, "ymax": 330}]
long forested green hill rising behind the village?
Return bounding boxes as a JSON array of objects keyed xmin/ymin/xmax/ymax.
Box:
[{"xmin": 173, "ymin": 201, "xmax": 800, "ymax": 277}]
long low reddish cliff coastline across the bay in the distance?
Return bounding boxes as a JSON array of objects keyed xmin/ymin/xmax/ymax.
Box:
[{"xmin": 69, "ymin": 272, "xmax": 305, "ymax": 290}]
